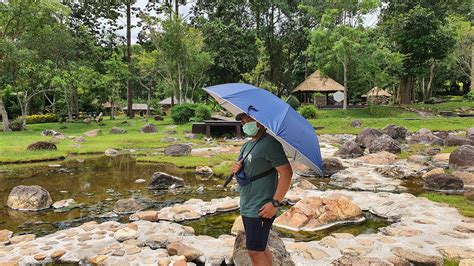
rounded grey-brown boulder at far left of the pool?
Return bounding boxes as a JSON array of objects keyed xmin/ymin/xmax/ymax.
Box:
[{"xmin": 7, "ymin": 186, "xmax": 53, "ymax": 211}]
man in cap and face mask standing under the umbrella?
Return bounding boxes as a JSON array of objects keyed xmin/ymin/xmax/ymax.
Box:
[{"xmin": 231, "ymin": 113, "xmax": 293, "ymax": 266}]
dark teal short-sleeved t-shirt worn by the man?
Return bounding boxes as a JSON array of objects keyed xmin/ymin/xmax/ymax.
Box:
[{"xmin": 240, "ymin": 133, "xmax": 288, "ymax": 218}]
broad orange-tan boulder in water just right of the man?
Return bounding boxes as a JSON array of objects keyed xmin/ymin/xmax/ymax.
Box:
[{"xmin": 275, "ymin": 197, "xmax": 364, "ymax": 231}]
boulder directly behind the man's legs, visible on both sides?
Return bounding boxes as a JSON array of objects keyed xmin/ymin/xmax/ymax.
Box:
[{"xmin": 232, "ymin": 230, "xmax": 295, "ymax": 266}]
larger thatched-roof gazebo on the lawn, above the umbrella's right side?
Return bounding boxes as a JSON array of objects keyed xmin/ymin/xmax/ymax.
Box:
[{"xmin": 292, "ymin": 70, "xmax": 344, "ymax": 106}]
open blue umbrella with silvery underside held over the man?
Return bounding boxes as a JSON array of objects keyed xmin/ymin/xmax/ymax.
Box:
[{"xmin": 204, "ymin": 83, "xmax": 323, "ymax": 176}]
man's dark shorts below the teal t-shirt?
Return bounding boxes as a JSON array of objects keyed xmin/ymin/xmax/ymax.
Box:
[{"xmin": 242, "ymin": 216, "xmax": 275, "ymax": 251}]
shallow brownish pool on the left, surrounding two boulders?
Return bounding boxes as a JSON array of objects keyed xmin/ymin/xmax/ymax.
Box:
[{"xmin": 0, "ymin": 155, "xmax": 237, "ymax": 235}]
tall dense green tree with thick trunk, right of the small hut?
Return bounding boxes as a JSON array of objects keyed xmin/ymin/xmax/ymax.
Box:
[{"xmin": 380, "ymin": 0, "xmax": 454, "ymax": 104}]
